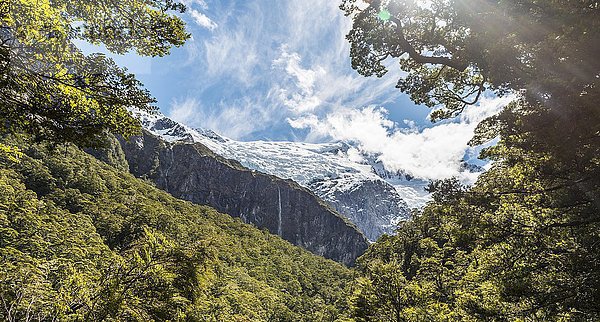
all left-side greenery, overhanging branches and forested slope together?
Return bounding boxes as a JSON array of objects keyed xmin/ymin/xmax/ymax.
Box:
[{"xmin": 0, "ymin": 0, "xmax": 360, "ymax": 321}]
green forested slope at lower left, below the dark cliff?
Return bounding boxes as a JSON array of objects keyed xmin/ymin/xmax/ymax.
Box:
[{"xmin": 0, "ymin": 143, "xmax": 353, "ymax": 321}]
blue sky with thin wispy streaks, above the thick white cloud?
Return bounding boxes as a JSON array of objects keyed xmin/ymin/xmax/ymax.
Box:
[{"xmin": 111, "ymin": 0, "xmax": 429, "ymax": 141}]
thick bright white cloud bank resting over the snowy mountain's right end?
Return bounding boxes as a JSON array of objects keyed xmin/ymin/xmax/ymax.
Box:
[{"xmin": 289, "ymin": 97, "xmax": 513, "ymax": 181}]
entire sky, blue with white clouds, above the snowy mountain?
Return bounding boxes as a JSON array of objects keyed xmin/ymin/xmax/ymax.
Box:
[{"xmin": 95, "ymin": 0, "xmax": 507, "ymax": 179}]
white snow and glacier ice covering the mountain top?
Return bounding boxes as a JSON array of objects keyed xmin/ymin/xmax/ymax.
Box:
[{"xmin": 134, "ymin": 111, "xmax": 429, "ymax": 208}]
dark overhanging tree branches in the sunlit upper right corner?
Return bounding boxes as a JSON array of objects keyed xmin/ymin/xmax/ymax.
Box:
[{"xmin": 341, "ymin": 0, "xmax": 600, "ymax": 119}]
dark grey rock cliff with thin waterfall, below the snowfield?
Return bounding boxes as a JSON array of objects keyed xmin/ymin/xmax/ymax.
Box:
[{"xmin": 121, "ymin": 132, "xmax": 368, "ymax": 265}]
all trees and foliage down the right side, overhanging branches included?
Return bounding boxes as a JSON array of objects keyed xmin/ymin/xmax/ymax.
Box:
[{"xmin": 342, "ymin": 0, "xmax": 600, "ymax": 321}]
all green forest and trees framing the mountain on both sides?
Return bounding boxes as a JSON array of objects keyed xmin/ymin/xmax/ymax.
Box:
[{"xmin": 0, "ymin": 0, "xmax": 600, "ymax": 321}]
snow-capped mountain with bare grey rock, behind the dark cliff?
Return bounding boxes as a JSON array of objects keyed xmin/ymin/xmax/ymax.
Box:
[{"xmin": 137, "ymin": 113, "xmax": 429, "ymax": 240}]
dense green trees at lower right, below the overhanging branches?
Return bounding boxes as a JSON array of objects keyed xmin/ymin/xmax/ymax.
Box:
[{"xmin": 352, "ymin": 107, "xmax": 600, "ymax": 321}]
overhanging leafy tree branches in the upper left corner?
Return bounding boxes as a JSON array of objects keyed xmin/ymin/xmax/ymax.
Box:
[{"xmin": 0, "ymin": 0, "xmax": 189, "ymax": 145}]
